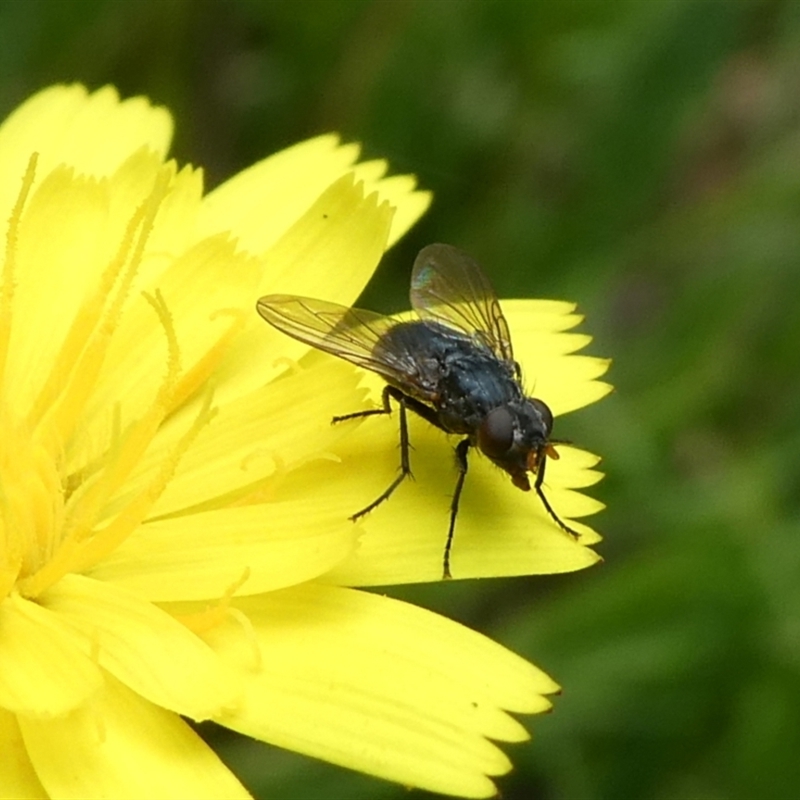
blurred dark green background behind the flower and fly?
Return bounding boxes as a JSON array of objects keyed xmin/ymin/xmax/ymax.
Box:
[{"xmin": 6, "ymin": 0, "xmax": 800, "ymax": 800}]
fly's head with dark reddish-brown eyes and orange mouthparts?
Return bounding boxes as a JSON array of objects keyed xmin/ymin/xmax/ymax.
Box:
[{"xmin": 477, "ymin": 397, "xmax": 558, "ymax": 492}]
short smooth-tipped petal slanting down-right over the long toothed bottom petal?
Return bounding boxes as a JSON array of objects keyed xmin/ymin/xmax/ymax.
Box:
[{"xmin": 41, "ymin": 575, "xmax": 238, "ymax": 720}]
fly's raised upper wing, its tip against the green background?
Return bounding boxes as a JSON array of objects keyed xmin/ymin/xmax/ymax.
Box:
[{"xmin": 411, "ymin": 244, "xmax": 514, "ymax": 363}]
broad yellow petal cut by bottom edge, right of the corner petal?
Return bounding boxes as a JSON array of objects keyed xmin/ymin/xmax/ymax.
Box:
[{"xmin": 20, "ymin": 678, "xmax": 250, "ymax": 800}]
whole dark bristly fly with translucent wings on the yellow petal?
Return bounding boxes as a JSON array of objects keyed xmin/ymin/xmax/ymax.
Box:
[{"xmin": 257, "ymin": 244, "xmax": 578, "ymax": 578}]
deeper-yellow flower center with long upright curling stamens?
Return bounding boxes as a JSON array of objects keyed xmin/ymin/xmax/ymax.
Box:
[{"xmin": 0, "ymin": 156, "xmax": 213, "ymax": 600}]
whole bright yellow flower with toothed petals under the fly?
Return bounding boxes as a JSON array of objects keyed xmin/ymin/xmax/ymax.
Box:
[{"xmin": 0, "ymin": 86, "xmax": 605, "ymax": 798}]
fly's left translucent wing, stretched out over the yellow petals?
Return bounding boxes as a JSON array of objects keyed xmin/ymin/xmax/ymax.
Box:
[{"xmin": 256, "ymin": 294, "xmax": 419, "ymax": 386}]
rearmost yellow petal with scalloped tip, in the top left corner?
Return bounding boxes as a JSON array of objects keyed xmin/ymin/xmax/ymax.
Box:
[{"xmin": 0, "ymin": 85, "xmax": 172, "ymax": 220}]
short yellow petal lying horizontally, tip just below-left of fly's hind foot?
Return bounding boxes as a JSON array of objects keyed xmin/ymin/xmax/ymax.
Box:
[{"xmin": 91, "ymin": 496, "xmax": 357, "ymax": 601}]
